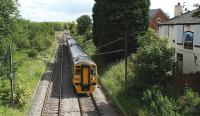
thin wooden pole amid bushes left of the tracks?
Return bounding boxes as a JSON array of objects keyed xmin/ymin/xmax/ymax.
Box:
[{"xmin": 9, "ymin": 44, "xmax": 14, "ymax": 107}]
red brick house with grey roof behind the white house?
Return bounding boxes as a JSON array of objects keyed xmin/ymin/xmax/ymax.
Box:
[{"xmin": 149, "ymin": 8, "xmax": 169, "ymax": 32}]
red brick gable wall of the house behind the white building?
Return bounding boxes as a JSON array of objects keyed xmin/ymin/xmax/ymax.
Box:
[{"xmin": 150, "ymin": 9, "xmax": 169, "ymax": 32}]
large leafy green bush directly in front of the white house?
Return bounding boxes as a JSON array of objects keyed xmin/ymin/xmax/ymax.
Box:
[{"xmin": 132, "ymin": 30, "xmax": 175, "ymax": 94}]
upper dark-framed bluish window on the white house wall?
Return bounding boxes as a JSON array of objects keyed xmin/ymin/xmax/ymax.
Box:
[{"xmin": 183, "ymin": 31, "xmax": 194, "ymax": 49}]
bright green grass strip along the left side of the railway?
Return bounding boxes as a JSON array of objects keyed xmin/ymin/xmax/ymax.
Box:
[{"xmin": 0, "ymin": 38, "xmax": 57, "ymax": 116}]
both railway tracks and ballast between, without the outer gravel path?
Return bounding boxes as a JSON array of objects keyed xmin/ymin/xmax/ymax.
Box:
[{"xmin": 41, "ymin": 41, "xmax": 114, "ymax": 116}]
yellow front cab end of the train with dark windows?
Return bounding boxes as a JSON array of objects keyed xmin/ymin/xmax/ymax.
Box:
[{"xmin": 73, "ymin": 63, "xmax": 98, "ymax": 94}]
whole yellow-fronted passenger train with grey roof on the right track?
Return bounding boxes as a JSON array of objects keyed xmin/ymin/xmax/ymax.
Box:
[{"xmin": 67, "ymin": 36, "xmax": 98, "ymax": 94}]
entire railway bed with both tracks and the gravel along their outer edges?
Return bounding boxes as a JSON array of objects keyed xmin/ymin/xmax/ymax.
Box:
[{"xmin": 29, "ymin": 40, "xmax": 117, "ymax": 116}]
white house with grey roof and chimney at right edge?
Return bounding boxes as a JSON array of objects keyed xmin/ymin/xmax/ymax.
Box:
[{"xmin": 159, "ymin": 4, "xmax": 200, "ymax": 74}]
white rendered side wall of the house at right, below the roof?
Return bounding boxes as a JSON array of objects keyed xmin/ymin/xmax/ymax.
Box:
[{"xmin": 159, "ymin": 24, "xmax": 200, "ymax": 73}]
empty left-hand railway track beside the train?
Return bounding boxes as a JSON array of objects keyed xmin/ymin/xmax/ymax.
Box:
[{"xmin": 41, "ymin": 44, "xmax": 63, "ymax": 116}]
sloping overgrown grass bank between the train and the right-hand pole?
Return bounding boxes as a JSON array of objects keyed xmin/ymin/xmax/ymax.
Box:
[{"xmin": 96, "ymin": 57, "xmax": 145, "ymax": 116}]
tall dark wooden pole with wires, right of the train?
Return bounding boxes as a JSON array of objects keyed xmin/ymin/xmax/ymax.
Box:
[{"xmin": 124, "ymin": 31, "xmax": 127, "ymax": 91}]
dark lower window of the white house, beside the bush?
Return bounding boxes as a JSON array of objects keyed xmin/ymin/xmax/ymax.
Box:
[{"xmin": 177, "ymin": 53, "xmax": 183, "ymax": 74}]
